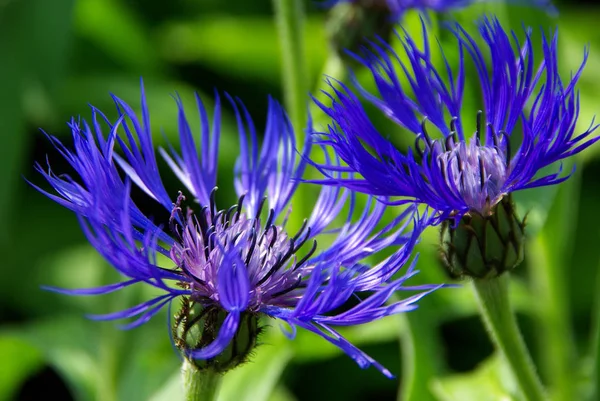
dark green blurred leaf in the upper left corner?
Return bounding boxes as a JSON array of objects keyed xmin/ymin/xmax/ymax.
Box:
[{"xmin": 0, "ymin": 0, "xmax": 73, "ymax": 241}]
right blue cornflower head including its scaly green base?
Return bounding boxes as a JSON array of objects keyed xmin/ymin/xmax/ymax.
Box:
[{"xmin": 315, "ymin": 17, "xmax": 598, "ymax": 277}]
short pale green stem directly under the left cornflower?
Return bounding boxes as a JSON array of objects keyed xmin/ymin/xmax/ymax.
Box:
[{"xmin": 181, "ymin": 359, "xmax": 222, "ymax": 401}]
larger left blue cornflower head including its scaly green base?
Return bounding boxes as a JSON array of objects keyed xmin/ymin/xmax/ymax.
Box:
[{"xmin": 36, "ymin": 83, "xmax": 439, "ymax": 376}]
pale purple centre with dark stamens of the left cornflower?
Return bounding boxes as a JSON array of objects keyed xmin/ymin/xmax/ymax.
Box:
[{"xmin": 170, "ymin": 191, "xmax": 316, "ymax": 311}]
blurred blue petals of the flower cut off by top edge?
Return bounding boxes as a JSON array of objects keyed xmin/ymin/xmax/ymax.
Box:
[{"xmin": 325, "ymin": 0, "xmax": 556, "ymax": 20}]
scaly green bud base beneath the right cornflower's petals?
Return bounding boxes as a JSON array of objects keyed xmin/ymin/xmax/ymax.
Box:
[{"xmin": 440, "ymin": 195, "xmax": 525, "ymax": 279}]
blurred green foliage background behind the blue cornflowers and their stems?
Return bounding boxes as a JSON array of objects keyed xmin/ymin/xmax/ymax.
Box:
[{"xmin": 0, "ymin": 0, "xmax": 600, "ymax": 401}]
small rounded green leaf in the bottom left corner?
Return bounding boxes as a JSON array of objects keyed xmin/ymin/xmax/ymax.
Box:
[{"xmin": 0, "ymin": 334, "xmax": 44, "ymax": 400}]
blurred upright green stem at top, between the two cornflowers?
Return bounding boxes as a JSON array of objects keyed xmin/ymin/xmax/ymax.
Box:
[{"xmin": 273, "ymin": 0, "xmax": 309, "ymax": 138}]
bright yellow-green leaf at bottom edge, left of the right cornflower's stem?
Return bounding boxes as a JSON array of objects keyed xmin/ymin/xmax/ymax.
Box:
[{"xmin": 432, "ymin": 356, "xmax": 517, "ymax": 401}]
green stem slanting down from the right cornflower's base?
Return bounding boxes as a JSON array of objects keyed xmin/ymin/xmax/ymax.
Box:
[{"xmin": 473, "ymin": 274, "xmax": 547, "ymax": 401}]
